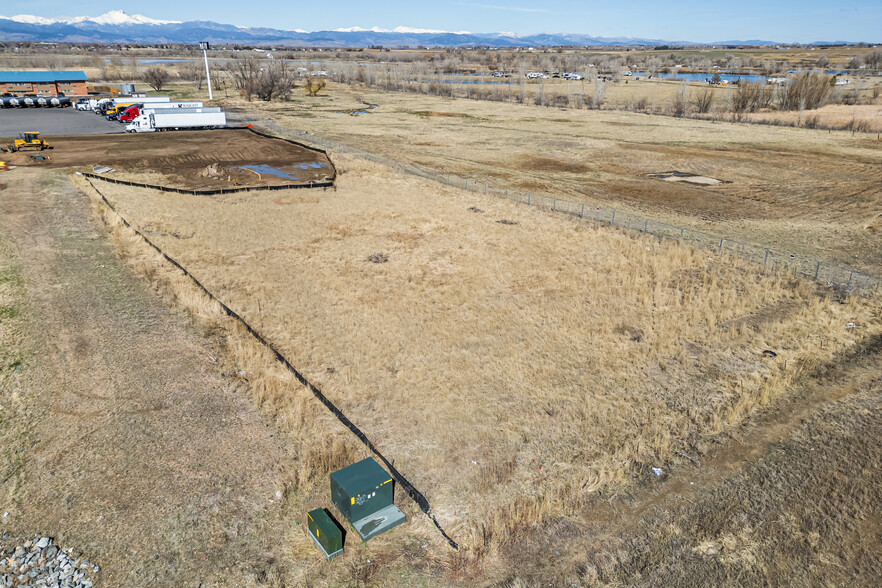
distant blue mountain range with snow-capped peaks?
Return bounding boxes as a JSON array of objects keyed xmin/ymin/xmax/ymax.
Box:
[{"xmin": 0, "ymin": 10, "xmax": 844, "ymax": 47}]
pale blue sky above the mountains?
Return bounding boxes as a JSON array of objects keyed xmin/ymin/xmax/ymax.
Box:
[{"xmin": 8, "ymin": 0, "xmax": 882, "ymax": 43}]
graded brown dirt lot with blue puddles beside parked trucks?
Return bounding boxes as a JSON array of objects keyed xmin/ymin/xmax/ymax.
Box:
[{"xmin": 4, "ymin": 129, "xmax": 335, "ymax": 189}]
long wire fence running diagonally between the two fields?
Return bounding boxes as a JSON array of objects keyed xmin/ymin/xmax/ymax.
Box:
[{"xmin": 237, "ymin": 120, "xmax": 882, "ymax": 293}]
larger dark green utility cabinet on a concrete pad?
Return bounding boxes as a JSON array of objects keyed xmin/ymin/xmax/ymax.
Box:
[{"xmin": 331, "ymin": 457, "xmax": 407, "ymax": 541}]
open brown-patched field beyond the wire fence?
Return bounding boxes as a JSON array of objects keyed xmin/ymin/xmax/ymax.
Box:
[{"xmin": 222, "ymin": 86, "xmax": 882, "ymax": 274}]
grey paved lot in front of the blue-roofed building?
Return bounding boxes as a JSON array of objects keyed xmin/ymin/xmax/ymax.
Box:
[{"xmin": 0, "ymin": 108, "xmax": 125, "ymax": 140}]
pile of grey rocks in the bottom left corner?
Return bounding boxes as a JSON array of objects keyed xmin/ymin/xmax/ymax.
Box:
[{"xmin": 0, "ymin": 534, "xmax": 101, "ymax": 588}]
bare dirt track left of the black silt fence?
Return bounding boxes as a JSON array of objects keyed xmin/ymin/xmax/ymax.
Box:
[{"xmin": 0, "ymin": 169, "xmax": 286, "ymax": 586}]
